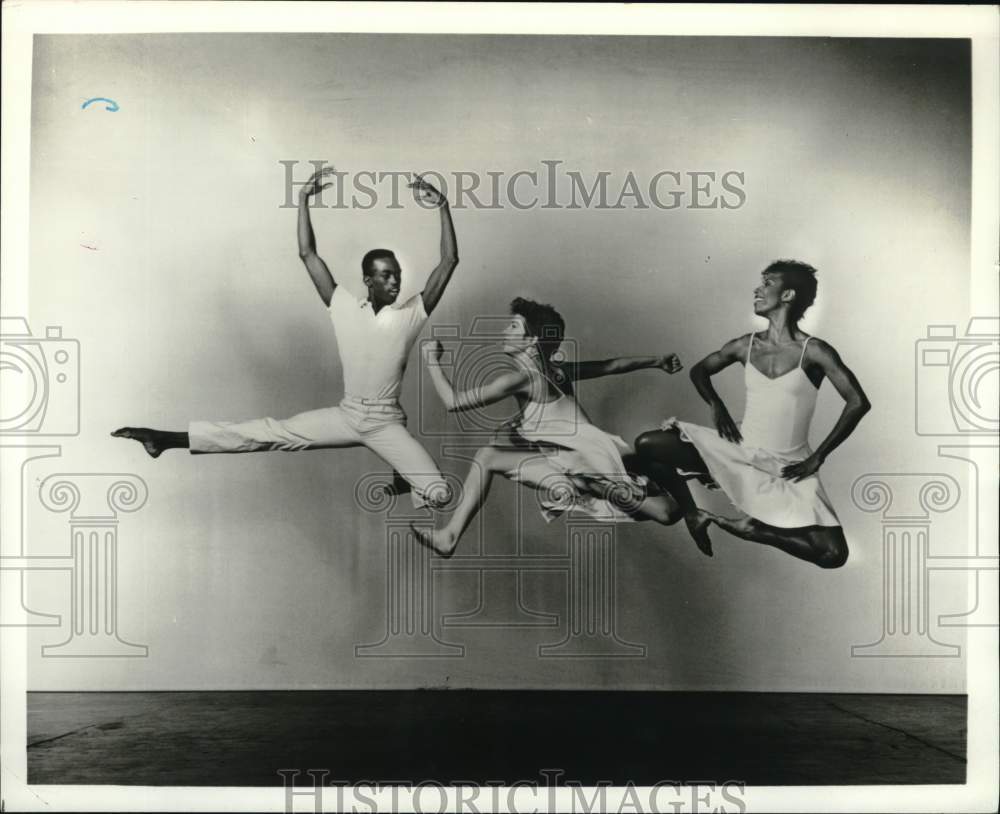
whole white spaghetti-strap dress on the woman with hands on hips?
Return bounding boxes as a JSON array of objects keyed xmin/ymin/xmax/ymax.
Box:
[{"xmin": 663, "ymin": 334, "xmax": 840, "ymax": 528}]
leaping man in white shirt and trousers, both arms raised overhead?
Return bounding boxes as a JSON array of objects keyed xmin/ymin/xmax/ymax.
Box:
[{"xmin": 112, "ymin": 167, "xmax": 458, "ymax": 507}]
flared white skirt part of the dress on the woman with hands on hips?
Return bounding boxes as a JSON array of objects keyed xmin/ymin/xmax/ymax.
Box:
[{"xmin": 662, "ymin": 418, "xmax": 840, "ymax": 529}]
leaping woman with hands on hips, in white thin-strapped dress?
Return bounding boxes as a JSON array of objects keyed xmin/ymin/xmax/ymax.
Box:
[{"xmin": 635, "ymin": 260, "xmax": 871, "ymax": 568}]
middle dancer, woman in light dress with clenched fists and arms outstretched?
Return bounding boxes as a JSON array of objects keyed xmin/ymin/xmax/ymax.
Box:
[{"xmin": 412, "ymin": 298, "xmax": 681, "ymax": 557}]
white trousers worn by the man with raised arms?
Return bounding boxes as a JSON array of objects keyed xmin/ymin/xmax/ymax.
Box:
[{"xmin": 188, "ymin": 396, "xmax": 445, "ymax": 507}]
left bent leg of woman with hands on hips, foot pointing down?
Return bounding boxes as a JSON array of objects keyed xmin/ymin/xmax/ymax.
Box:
[{"xmin": 635, "ymin": 430, "xmax": 713, "ymax": 557}]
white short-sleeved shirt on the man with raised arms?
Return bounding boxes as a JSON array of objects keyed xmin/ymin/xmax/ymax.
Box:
[{"xmin": 329, "ymin": 285, "xmax": 427, "ymax": 399}]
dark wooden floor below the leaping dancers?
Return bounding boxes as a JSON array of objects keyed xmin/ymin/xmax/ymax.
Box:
[{"xmin": 28, "ymin": 691, "xmax": 966, "ymax": 786}]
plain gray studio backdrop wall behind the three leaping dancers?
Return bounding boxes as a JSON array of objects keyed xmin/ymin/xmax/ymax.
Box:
[{"xmin": 24, "ymin": 34, "xmax": 970, "ymax": 692}]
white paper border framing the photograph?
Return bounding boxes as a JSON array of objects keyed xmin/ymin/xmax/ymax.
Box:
[{"xmin": 0, "ymin": 0, "xmax": 1000, "ymax": 812}]
